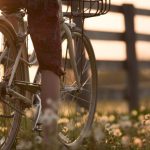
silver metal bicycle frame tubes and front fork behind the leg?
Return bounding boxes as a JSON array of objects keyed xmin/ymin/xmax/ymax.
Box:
[{"xmin": 0, "ymin": 0, "xmax": 81, "ymax": 105}]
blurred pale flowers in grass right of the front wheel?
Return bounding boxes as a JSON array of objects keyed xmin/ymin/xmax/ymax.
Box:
[{"xmin": 87, "ymin": 108, "xmax": 150, "ymax": 150}]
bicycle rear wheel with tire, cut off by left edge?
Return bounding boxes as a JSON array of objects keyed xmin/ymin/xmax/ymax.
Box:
[{"xmin": 0, "ymin": 23, "xmax": 25, "ymax": 150}]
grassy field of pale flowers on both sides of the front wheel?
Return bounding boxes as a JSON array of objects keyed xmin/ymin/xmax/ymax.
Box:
[{"xmin": 14, "ymin": 100, "xmax": 150, "ymax": 150}]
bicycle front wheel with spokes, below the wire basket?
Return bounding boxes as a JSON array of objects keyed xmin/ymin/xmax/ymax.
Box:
[{"xmin": 58, "ymin": 27, "xmax": 97, "ymax": 148}]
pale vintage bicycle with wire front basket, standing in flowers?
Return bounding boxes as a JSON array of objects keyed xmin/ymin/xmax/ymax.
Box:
[{"xmin": 0, "ymin": 0, "xmax": 110, "ymax": 150}]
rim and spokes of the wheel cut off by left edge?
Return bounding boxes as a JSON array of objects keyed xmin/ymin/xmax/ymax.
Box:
[{"xmin": 0, "ymin": 27, "xmax": 20, "ymax": 149}]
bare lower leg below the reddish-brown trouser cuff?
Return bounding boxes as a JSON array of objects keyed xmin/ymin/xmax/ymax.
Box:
[{"xmin": 41, "ymin": 70, "xmax": 60, "ymax": 150}]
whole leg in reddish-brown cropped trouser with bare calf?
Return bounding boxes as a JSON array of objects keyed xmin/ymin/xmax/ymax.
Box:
[{"xmin": 29, "ymin": 3, "xmax": 63, "ymax": 149}]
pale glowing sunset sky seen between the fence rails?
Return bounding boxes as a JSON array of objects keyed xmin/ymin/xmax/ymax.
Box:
[{"xmin": 85, "ymin": 0, "xmax": 150, "ymax": 60}]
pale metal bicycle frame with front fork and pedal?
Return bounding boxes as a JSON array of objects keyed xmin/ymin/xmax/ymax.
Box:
[{"xmin": 0, "ymin": 0, "xmax": 81, "ymax": 107}]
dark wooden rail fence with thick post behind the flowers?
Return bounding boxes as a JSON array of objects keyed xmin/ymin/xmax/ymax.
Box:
[{"xmin": 87, "ymin": 4, "xmax": 150, "ymax": 109}]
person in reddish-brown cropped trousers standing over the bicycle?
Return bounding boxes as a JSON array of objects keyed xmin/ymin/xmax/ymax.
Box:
[{"xmin": 0, "ymin": 0, "xmax": 64, "ymax": 149}]
